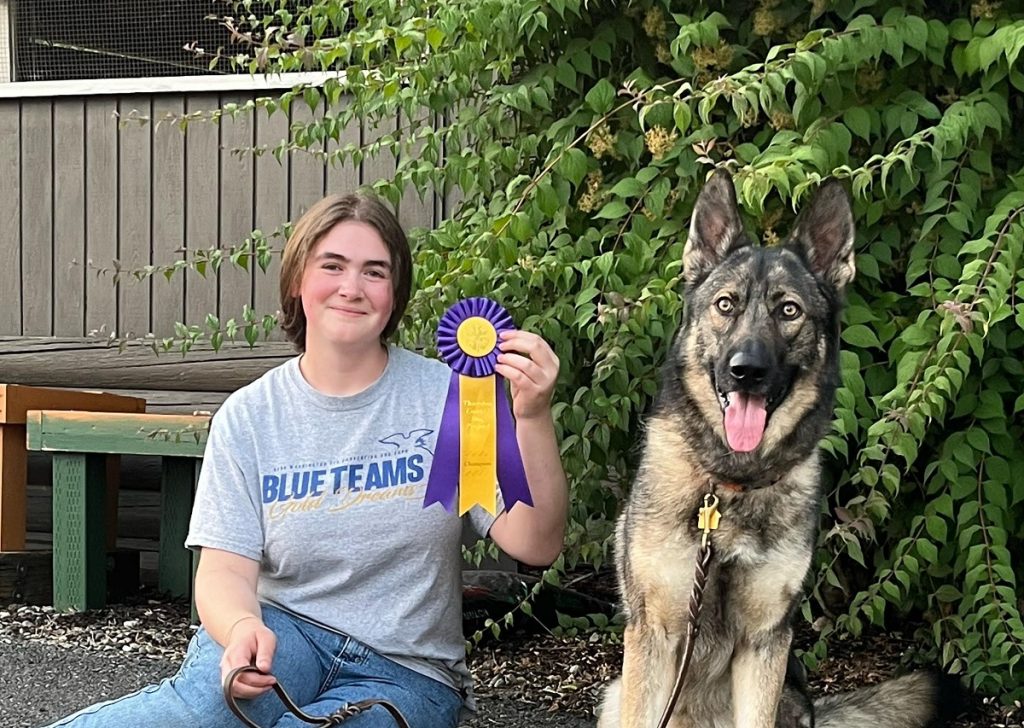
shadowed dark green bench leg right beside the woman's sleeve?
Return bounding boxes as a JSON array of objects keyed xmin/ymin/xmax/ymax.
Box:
[{"xmin": 159, "ymin": 458, "xmax": 197, "ymax": 597}]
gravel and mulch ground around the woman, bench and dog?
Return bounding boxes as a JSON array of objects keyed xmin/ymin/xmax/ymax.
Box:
[{"xmin": 0, "ymin": 601, "xmax": 1024, "ymax": 728}]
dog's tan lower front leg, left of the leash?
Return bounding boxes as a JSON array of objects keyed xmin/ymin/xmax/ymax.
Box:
[{"xmin": 621, "ymin": 622, "xmax": 688, "ymax": 728}]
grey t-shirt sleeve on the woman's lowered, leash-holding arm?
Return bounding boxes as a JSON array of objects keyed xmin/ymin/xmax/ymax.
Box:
[{"xmin": 185, "ymin": 401, "xmax": 264, "ymax": 561}]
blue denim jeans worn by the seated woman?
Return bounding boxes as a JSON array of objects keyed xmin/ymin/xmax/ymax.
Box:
[{"xmin": 46, "ymin": 604, "xmax": 462, "ymax": 728}]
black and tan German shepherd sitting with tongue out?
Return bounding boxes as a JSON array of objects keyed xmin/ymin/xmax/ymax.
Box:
[{"xmin": 598, "ymin": 172, "xmax": 956, "ymax": 728}]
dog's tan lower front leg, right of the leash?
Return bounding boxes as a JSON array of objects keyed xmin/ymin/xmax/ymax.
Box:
[{"xmin": 732, "ymin": 627, "xmax": 793, "ymax": 728}]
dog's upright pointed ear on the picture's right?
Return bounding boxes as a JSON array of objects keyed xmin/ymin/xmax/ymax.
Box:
[{"xmin": 787, "ymin": 179, "xmax": 856, "ymax": 293}]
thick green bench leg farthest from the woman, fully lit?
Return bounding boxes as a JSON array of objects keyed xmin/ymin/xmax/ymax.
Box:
[{"xmin": 53, "ymin": 453, "xmax": 106, "ymax": 610}]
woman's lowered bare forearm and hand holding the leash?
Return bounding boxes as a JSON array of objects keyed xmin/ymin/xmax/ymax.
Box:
[{"xmin": 196, "ymin": 549, "xmax": 278, "ymax": 698}]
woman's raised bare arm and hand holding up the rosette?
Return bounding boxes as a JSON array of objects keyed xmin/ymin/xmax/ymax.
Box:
[{"xmin": 490, "ymin": 331, "xmax": 568, "ymax": 566}]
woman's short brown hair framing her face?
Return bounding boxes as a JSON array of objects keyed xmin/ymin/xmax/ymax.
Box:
[{"xmin": 281, "ymin": 192, "xmax": 413, "ymax": 351}]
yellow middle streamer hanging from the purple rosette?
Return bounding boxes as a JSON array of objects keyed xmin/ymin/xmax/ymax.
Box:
[{"xmin": 459, "ymin": 375, "xmax": 498, "ymax": 516}]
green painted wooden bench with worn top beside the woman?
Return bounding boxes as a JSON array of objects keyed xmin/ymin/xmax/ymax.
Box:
[{"xmin": 26, "ymin": 410, "xmax": 210, "ymax": 610}]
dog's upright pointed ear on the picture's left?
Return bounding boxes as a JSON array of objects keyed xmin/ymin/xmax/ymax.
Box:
[{"xmin": 683, "ymin": 170, "xmax": 744, "ymax": 284}]
